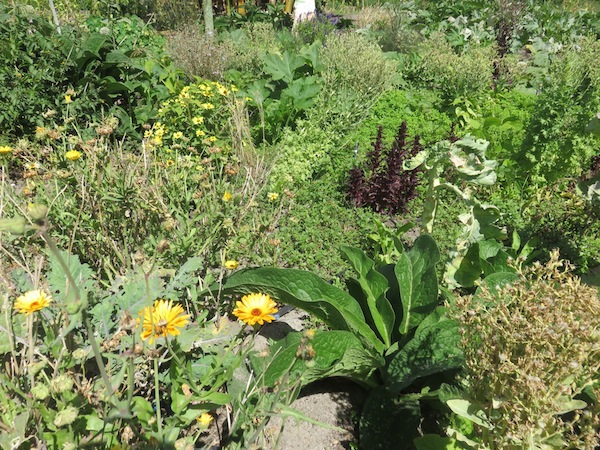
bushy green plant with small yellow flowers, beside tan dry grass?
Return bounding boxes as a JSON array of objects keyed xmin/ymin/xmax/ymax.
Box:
[{"xmin": 144, "ymin": 81, "xmax": 237, "ymax": 156}]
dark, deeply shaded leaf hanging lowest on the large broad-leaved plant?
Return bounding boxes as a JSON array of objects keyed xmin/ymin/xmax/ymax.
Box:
[{"xmin": 360, "ymin": 387, "xmax": 421, "ymax": 450}]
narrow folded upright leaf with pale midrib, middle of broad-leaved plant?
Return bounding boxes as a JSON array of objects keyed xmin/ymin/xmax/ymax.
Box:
[{"xmin": 341, "ymin": 246, "xmax": 396, "ymax": 348}]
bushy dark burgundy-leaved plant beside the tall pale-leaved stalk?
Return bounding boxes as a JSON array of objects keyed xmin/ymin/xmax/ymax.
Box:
[{"xmin": 348, "ymin": 122, "xmax": 423, "ymax": 214}]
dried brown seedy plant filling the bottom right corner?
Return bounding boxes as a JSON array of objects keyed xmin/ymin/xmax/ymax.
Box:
[{"xmin": 457, "ymin": 251, "xmax": 600, "ymax": 449}]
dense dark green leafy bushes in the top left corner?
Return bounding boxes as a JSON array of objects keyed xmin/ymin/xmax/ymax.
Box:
[{"xmin": 0, "ymin": 6, "xmax": 183, "ymax": 137}]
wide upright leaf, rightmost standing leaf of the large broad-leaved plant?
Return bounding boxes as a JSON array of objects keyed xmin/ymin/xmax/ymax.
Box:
[{"xmin": 392, "ymin": 234, "xmax": 440, "ymax": 335}]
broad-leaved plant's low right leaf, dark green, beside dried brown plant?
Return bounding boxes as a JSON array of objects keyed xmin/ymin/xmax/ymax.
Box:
[{"xmin": 385, "ymin": 312, "xmax": 463, "ymax": 392}]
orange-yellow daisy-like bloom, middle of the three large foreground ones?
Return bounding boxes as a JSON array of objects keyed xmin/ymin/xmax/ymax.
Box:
[{"xmin": 140, "ymin": 300, "xmax": 190, "ymax": 343}]
